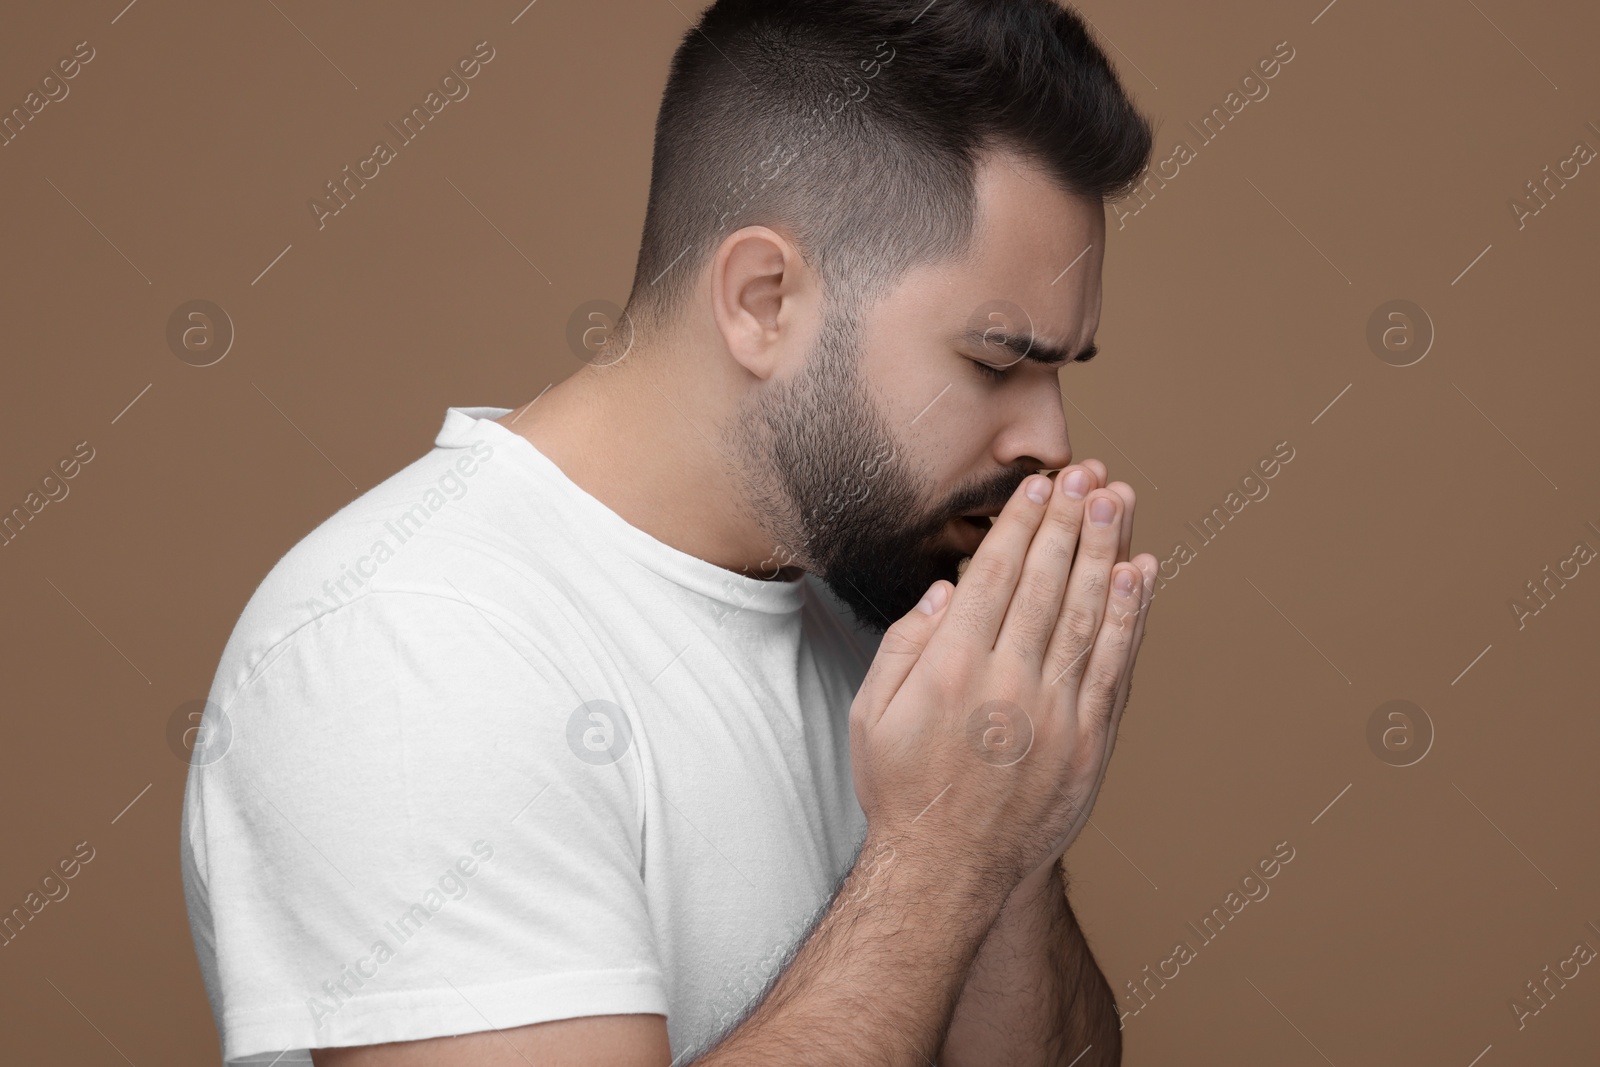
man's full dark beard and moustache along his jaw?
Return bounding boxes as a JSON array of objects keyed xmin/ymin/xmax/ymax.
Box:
[{"xmin": 736, "ymin": 300, "xmax": 1029, "ymax": 633}]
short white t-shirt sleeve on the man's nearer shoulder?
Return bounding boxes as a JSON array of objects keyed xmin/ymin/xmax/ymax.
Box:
[{"xmin": 184, "ymin": 592, "xmax": 667, "ymax": 1062}]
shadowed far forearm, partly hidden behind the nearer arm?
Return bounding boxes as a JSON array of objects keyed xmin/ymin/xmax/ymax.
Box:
[{"xmin": 939, "ymin": 864, "xmax": 1122, "ymax": 1067}]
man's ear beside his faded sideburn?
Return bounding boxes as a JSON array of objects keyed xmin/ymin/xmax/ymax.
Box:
[{"xmin": 710, "ymin": 226, "xmax": 819, "ymax": 379}]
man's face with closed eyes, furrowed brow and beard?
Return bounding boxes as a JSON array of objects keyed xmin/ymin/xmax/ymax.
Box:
[{"xmin": 732, "ymin": 157, "xmax": 1106, "ymax": 632}]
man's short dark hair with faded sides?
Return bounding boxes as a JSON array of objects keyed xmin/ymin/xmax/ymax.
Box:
[{"xmin": 627, "ymin": 0, "xmax": 1152, "ymax": 334}]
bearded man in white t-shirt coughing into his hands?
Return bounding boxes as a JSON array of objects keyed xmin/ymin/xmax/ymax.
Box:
[{"xmin": 182, "ymin": 0, "xmax": 1155, "ymax": 1067}]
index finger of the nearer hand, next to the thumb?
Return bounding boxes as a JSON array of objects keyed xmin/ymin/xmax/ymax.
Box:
[{"xmin": 933, "ymin": 474, "xmax": 1051, "ymax": 654}]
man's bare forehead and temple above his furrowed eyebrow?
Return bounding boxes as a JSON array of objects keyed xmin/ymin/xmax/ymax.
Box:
[{"xmin": 882, "ymin": 154, "xmax": 1106, "ymax": 354}]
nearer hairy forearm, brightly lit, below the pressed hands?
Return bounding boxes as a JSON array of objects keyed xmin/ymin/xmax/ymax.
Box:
[{"xmin": 694, "ymin": 837, "xmax": 1005, "ymax": 1067}]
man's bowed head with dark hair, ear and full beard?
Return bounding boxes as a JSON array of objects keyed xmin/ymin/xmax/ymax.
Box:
[{"xmin": 604, "ymin": 0, "xmax": 1150, "ymax": 630}]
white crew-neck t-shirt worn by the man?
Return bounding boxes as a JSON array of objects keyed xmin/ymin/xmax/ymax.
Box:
[{"xmin": 181, "ymin": 408, "xmax": 878, "ymax": 1064}]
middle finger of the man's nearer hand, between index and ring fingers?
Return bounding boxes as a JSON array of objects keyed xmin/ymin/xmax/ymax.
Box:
[{"xmin": 995, "ymin": 466, "xmax": 1099, "ymax": 670}]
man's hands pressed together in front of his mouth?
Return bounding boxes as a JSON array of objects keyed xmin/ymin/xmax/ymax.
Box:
[{"xmin": 851, "ymin": 466, "xmax": 1155, "ymax": 893}]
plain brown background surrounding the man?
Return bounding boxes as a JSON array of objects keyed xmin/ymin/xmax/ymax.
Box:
[{"xmin": 0, "ymin": 0, "xmax": 1600, "ymax": 1067}]
